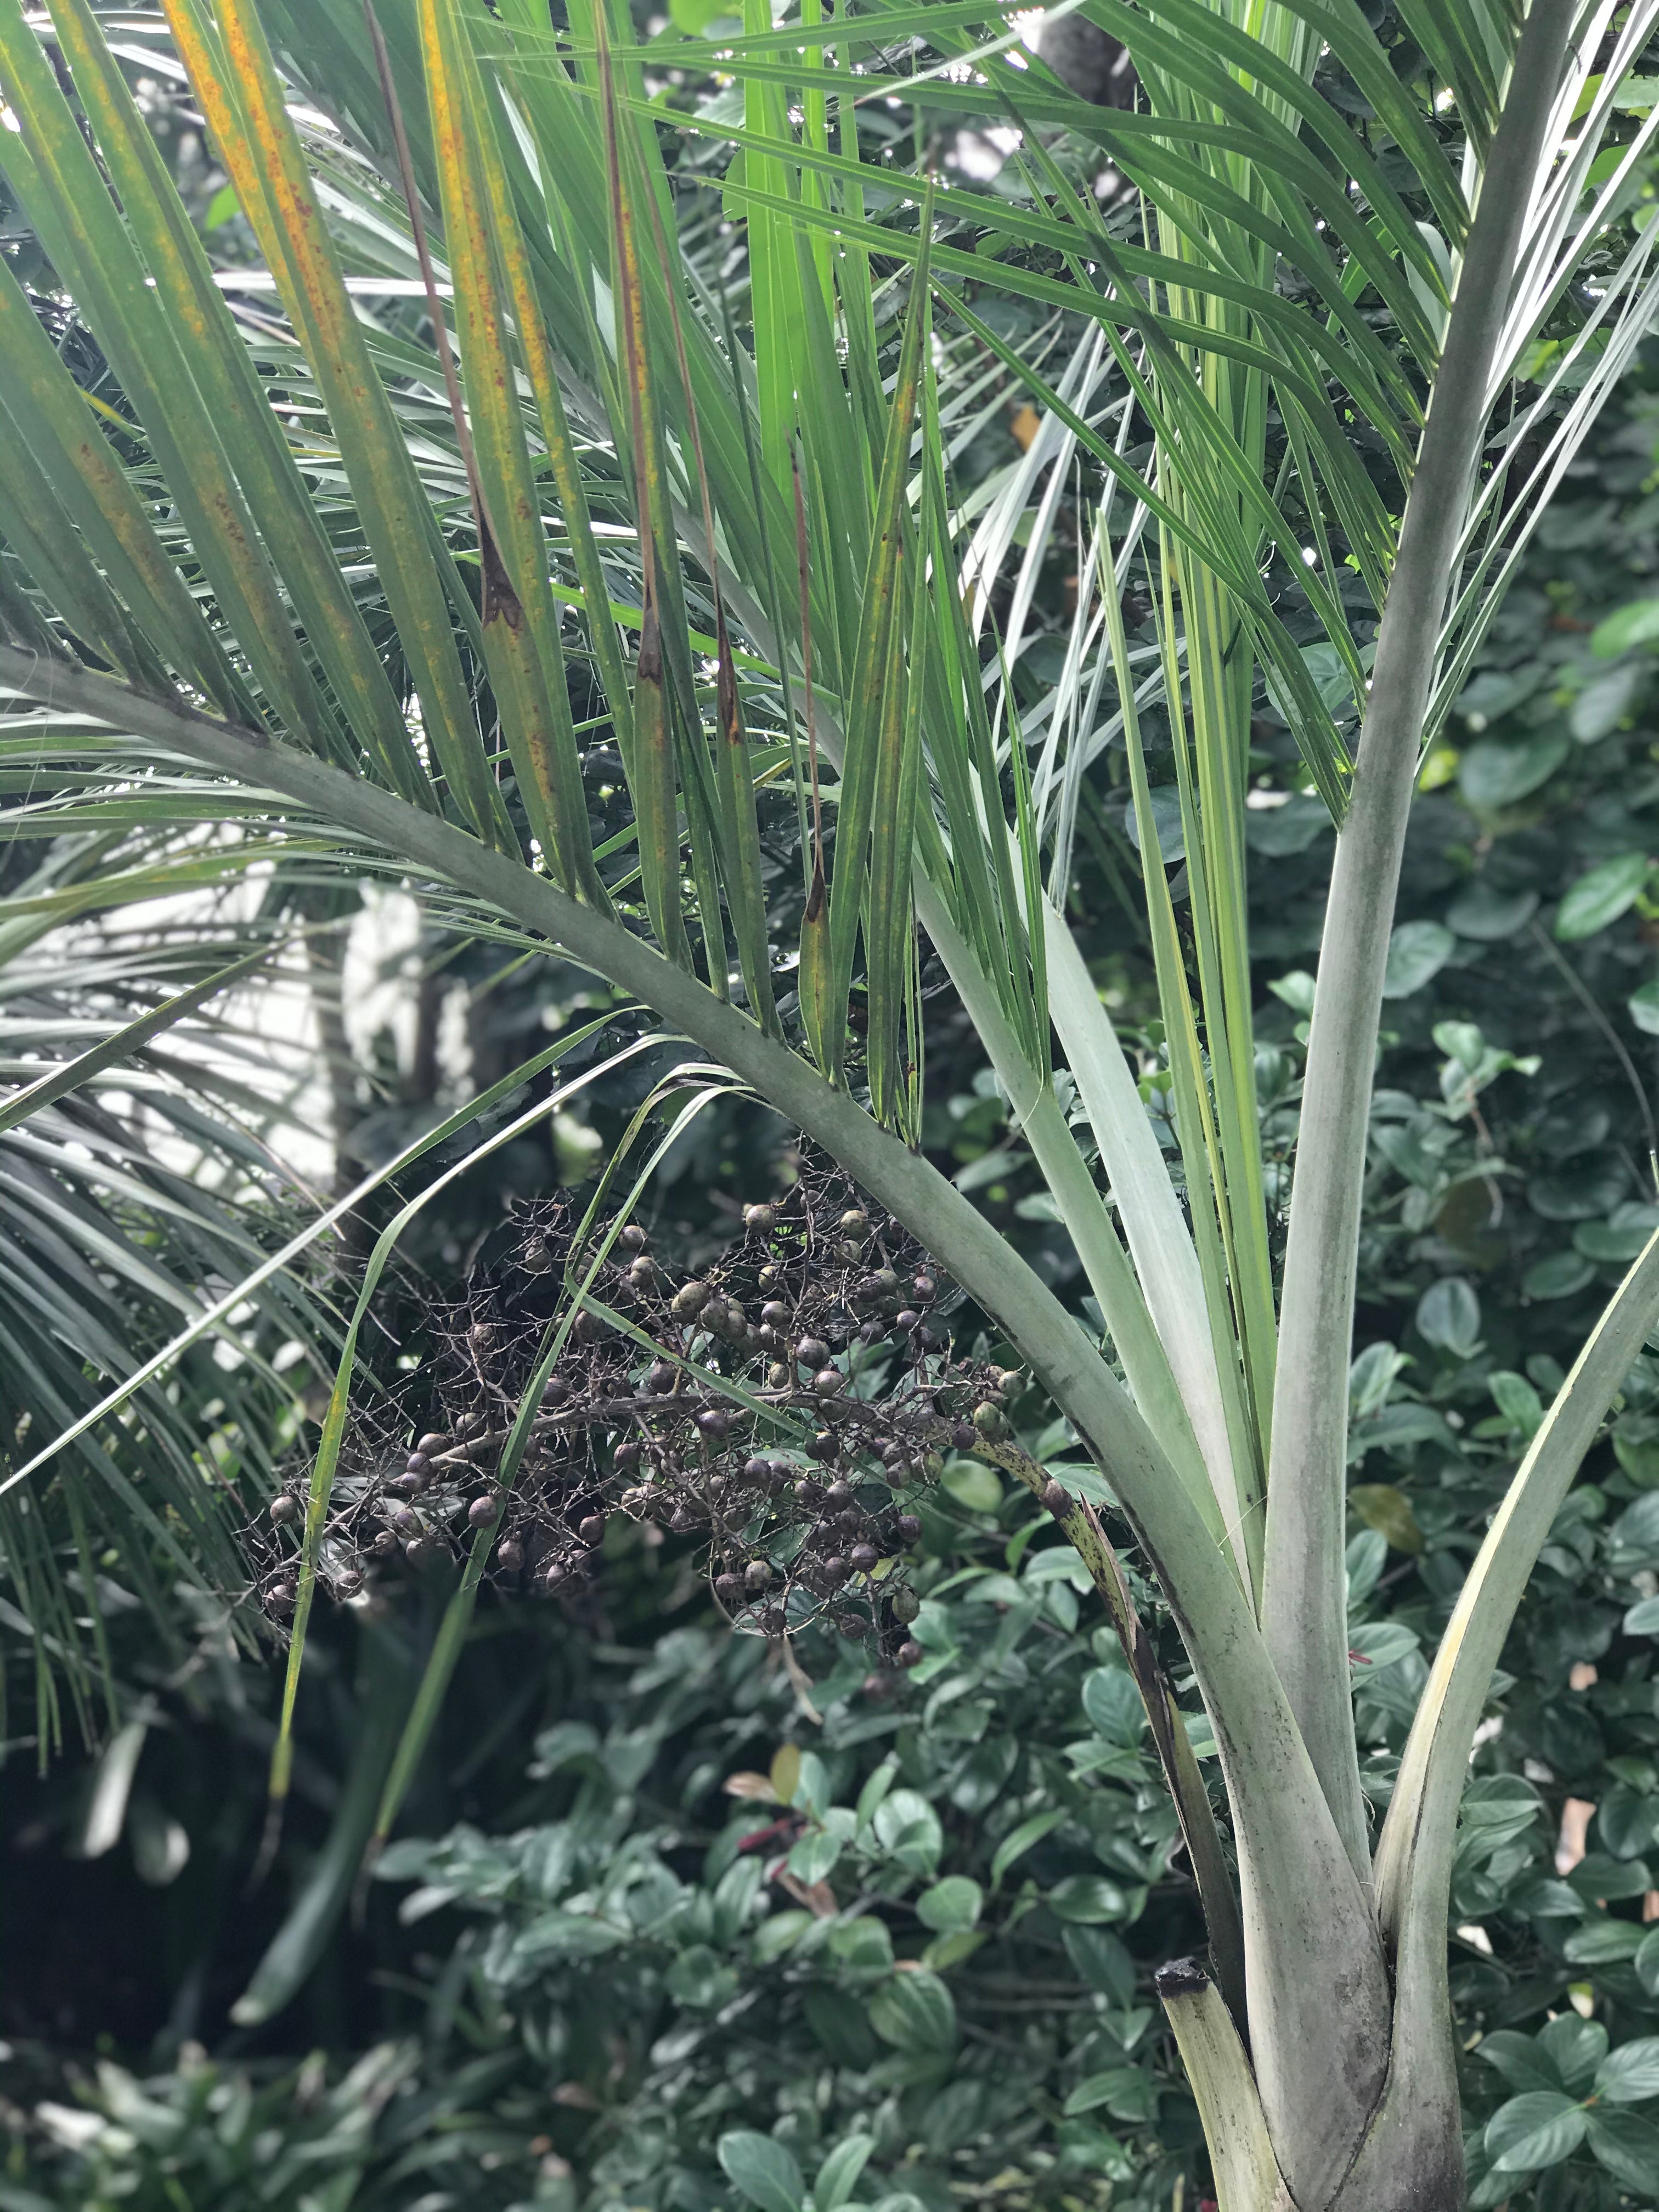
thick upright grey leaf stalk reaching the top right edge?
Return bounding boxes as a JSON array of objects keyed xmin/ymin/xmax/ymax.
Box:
[{"xmin": 1263, "ymin": 0, "xmax": 1573, "ymax": 1871}]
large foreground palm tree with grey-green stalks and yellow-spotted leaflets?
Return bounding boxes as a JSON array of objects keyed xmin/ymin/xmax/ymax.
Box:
[{"xmin": 0, "ymin": 0, "xmax": 1659, "ymax": 2212}]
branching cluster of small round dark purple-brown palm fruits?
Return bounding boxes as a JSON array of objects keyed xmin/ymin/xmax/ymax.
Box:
[{"xmin": 259, "ymin": 1153, "xmax": 1015, "ymax": 1666}]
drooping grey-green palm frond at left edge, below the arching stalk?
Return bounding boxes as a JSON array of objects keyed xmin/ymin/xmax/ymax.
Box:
[{"xmin": 0, "ymin": 862, "xmax": 332, "ymax": 1760}]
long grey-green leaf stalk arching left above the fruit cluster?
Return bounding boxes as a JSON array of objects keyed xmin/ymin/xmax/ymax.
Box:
[{"xmin": 0, "ymin": 646, "xmax": 1389, "ymax": 2205}]
